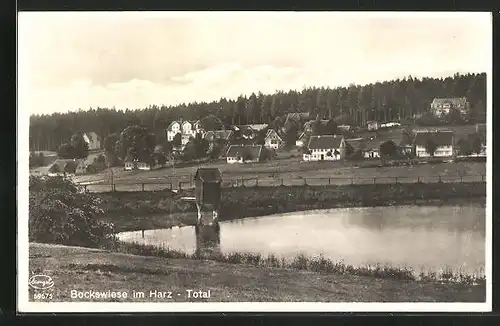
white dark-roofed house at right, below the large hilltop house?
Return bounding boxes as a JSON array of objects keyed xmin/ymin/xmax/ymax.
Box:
[{"xmin": 414, "ymin": 130, "xmax": 453, "ymax": 157}]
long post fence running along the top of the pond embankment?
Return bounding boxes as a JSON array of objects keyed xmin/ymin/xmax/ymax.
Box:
[{"xmin": 80, "ymin": 174, "xmax": 486, "ymax": 192}]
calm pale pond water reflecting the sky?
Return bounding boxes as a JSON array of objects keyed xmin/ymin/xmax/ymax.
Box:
[{"xmin": 118, "ymin": 204, "xmax": 486, "ymax": 274}]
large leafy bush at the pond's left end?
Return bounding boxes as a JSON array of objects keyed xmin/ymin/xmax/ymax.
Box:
[{"xmin": 29, "ymin": 176, "xmax": 117, "ymax": 248}]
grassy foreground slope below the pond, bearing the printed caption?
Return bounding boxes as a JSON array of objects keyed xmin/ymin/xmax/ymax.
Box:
[{"xmin": 29, "ymin": 243, "xmax": 485, "ymax": 302}]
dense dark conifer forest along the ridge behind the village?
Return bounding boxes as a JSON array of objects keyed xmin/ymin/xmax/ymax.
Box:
[{"xmin": 29, "ymin": 73, "xmax": 486, "ymax": 150}]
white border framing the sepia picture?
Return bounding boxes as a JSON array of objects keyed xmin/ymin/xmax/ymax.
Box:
[{"xmin": 16, "ymin": 12, "xmax": 493, "ymax": 313}]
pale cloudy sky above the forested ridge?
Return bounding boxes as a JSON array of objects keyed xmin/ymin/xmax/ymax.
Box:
[{"xmin": 18, "ymin": 12, "xmax": 492, "ymax": 114}]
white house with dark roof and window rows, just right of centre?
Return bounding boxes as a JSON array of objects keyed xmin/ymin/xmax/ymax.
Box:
[{"xmin": 303, "ymin": 135, "xmax": 346, "ymax": 161}]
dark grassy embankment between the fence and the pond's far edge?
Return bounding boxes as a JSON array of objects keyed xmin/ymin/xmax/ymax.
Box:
[{"xmin": 97, "ymin": 182, "xmax": 486, "ymax": 232}]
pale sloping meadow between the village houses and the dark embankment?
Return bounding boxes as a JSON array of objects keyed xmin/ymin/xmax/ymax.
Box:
[{"xmin": 74, "ymin": 157, "xmax": 486, "ymax": 191}]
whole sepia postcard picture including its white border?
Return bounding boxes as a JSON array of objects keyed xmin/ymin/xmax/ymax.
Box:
[{"xmin": 17, "ymin": 11, "xmax": 492, "ymax": 312}]
